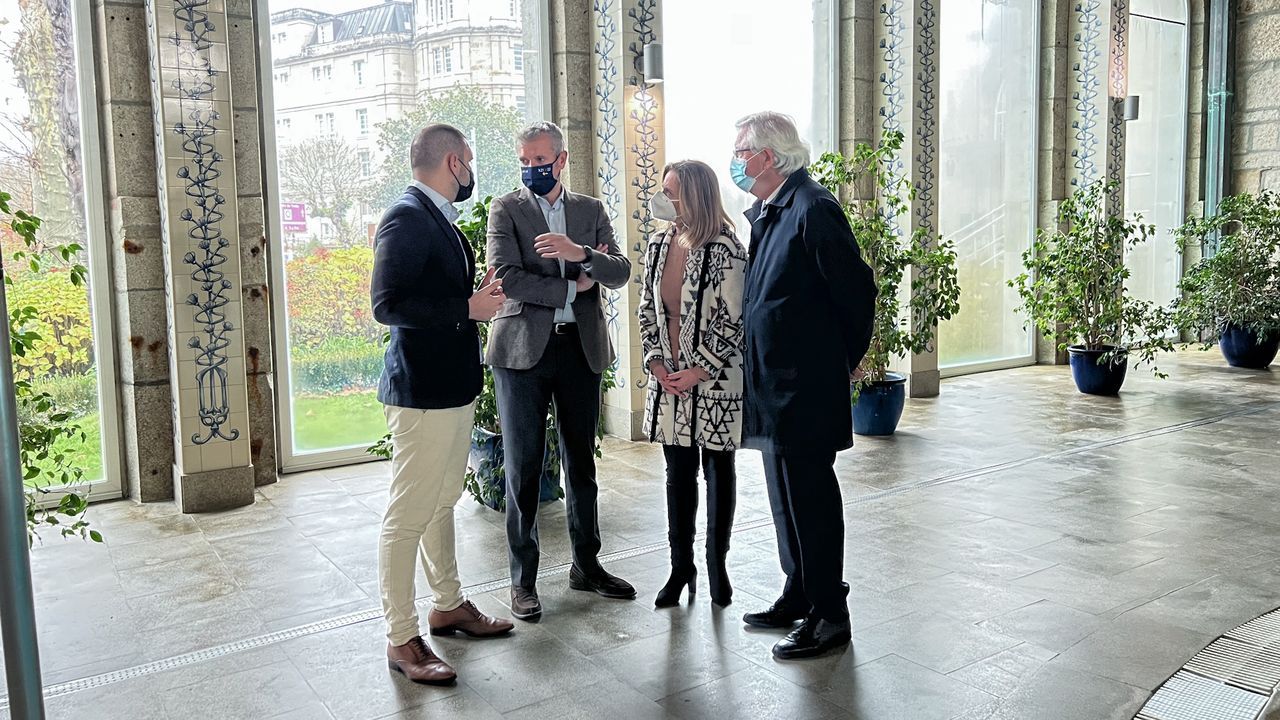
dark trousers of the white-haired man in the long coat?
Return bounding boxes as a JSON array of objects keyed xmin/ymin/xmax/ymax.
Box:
[{"xmin": 764, "ymin": 452, "xmax": 849, "ymax": 623}]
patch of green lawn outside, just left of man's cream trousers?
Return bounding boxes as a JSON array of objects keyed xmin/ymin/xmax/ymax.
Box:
[{"xmin": 293, "ymin": 391, "xmax": 387, "ymax": 451}]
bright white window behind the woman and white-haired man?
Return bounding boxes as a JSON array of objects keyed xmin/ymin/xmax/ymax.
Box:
[{"xmin": 662, "ymin": 0, "xmax": 840, "ymax": 242}]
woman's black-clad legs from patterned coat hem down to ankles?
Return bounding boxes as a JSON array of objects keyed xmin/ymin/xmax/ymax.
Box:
[{"xmin": 662, "ymin": 445, "xmax": 737, "ymax": 563}]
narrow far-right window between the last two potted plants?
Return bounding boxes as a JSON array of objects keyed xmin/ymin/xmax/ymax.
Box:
[{"xmin": 1125, "ymin": 0, "xmax": 1188, "ymax": 304}]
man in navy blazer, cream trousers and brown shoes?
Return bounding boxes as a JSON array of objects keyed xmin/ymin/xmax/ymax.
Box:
[{"xmin": 372, "ymin": 124, "xmax": 513, "ymax": 684}]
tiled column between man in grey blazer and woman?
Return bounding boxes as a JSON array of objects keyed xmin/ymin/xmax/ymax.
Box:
[{"xmin": 591, "ymin": 0, "xmax": 664, "ymax": 438}]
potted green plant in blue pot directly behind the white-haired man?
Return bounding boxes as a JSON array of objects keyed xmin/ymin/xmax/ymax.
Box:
[{"xmin": 810, "ymin": 132, "xmax": 960, "ymax": 436}]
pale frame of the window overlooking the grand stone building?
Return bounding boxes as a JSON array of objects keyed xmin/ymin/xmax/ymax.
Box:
[{"xmin": 256, "ymin": 0, "xmax": 553, "ymax": 474}]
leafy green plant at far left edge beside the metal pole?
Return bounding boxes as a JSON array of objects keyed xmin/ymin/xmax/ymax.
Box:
[{"xmin": 0, "ymin": 185, "xmax": 102, "ymax": 544}]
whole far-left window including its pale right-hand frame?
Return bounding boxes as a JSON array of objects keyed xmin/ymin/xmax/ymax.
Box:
[{"xmin": 0, "ymin": 0, "xmax": 122, "ymax": 497}]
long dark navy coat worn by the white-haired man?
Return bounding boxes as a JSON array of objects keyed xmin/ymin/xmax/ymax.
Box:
[{"xmin": 742, "ymin": 169, "xmax": 876, "ymax": 455}]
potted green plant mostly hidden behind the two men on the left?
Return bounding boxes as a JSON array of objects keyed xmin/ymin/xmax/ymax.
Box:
[{"xmin": 369, "ymin": 197, "xmax": 617, "ymax": 511}]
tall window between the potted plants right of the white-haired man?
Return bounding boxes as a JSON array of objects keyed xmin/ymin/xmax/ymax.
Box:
[{"xmin": 938, "ymin": 0, "xmax": 1039, "ymax": 369}]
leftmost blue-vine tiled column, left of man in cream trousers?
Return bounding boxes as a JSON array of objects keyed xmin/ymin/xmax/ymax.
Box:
[{"xmin": 147, "ymin": 0, "xmax": 255, "ymax": 512}]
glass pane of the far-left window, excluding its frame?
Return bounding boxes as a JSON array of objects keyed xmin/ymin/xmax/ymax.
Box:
[{"xmin": 0, "ymin": 0, "xmax": 110, "ymax": 480}]
